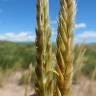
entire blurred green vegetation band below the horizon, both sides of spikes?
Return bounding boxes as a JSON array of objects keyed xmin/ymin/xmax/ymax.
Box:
[{"xmin": 0, "ymin": 41, "xmax": 96, "ymax": 77}]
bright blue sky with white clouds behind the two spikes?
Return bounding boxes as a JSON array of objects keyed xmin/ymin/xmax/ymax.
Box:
[{"xmin": 0, "ymin": 0, "xmax": 96, "ymax": 43}]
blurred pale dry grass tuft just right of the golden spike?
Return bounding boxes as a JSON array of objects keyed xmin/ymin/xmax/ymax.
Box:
[{"xmin": 73, "ymin": 44, "xmax": 87, "ymax": 83}]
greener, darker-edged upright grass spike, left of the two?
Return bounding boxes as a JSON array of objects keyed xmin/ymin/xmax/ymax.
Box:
[{"xmin": 35, "ymin": 0, "xmax": 53, "ymax": 96}]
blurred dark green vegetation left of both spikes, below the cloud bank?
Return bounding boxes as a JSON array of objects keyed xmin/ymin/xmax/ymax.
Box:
[{"xmin": 0, "ymin": 42, "xmax": 35, "ymax": 70}]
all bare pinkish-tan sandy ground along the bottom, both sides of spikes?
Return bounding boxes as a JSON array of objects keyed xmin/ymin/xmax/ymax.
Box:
[{"xmin": 0, "ymin": 72, "xmax": 96, "ymax": 96}]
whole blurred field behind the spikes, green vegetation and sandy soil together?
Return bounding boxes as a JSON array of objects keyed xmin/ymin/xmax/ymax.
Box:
[{"xmin": 0, "ymin": 41, "xmax": 96, "ymax": 96}]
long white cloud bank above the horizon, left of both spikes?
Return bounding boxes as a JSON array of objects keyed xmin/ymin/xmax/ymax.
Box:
[{"xmin": 0, "ymin": 32, "xmax": 35, "ymax": 42}]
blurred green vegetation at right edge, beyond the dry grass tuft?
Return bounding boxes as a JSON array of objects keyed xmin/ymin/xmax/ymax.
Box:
[{"xmin": 82, "ymin": 44, "xmax": 96, "ymax": 78}]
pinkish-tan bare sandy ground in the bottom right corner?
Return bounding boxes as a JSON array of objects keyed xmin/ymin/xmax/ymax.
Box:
[{"xmin": 73, "ymin": 77, "xmax": 96, "ymax": 96}]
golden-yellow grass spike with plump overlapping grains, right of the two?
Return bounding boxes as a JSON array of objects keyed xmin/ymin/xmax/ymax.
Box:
[{"xmin": 56, "ymin": 0, "xmax": 76, "ymax": 96}]
